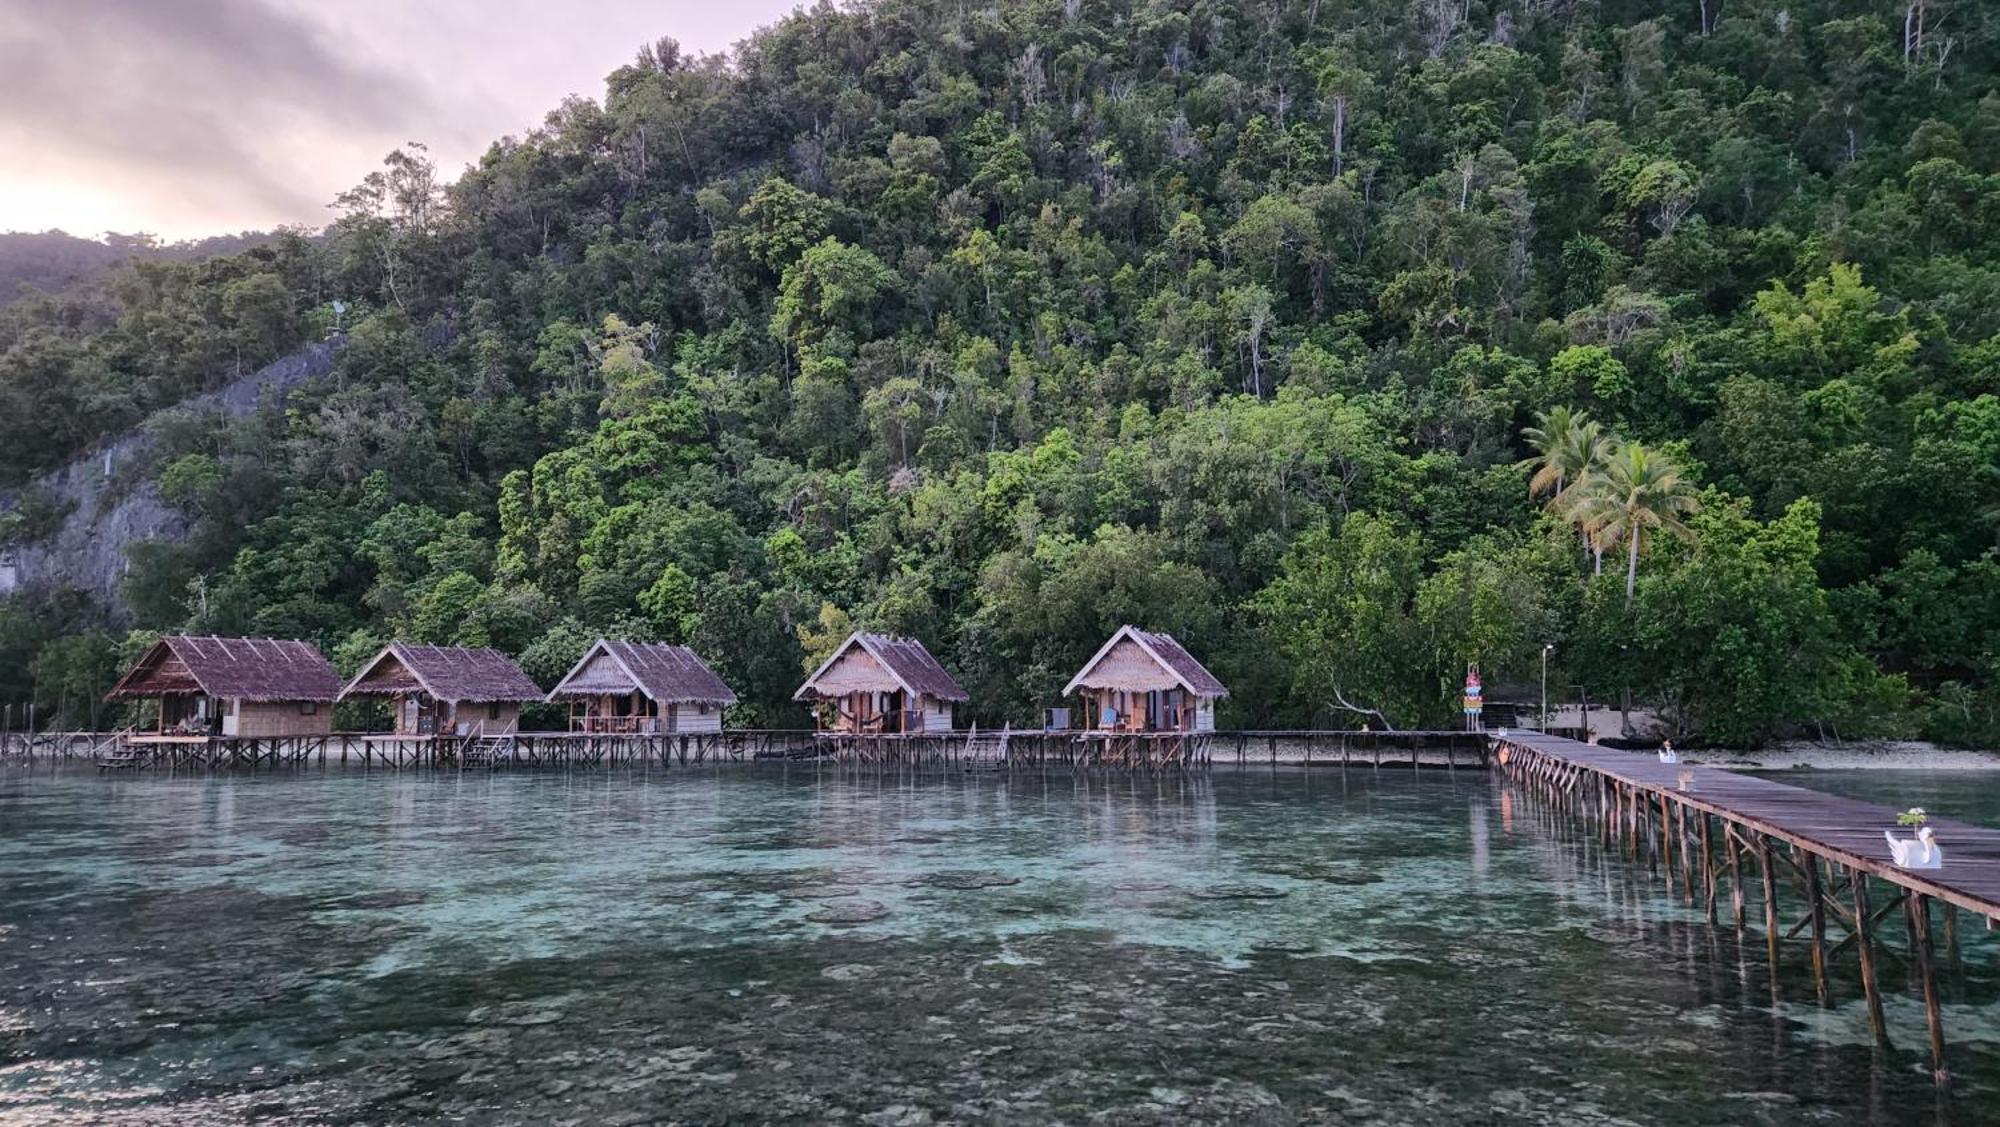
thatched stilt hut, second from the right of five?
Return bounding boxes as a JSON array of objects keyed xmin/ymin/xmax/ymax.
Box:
[{"xmin": 792, "ymin": 631, "xmax": 972, "ymax": 735}]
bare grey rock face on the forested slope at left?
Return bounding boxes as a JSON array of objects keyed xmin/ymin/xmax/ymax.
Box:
[{"xmin": 0, "ymin": 342, "xmax": 336, "ymax": 621}]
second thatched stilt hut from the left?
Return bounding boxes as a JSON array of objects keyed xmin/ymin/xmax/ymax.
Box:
[{"xmin": 340, "ymin": 641, "xmax": 542, "ymax": 737}]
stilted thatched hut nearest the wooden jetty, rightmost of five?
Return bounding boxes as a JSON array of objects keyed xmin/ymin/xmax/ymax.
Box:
[{"xmin": 1062, "ymin": 625, "xmax": 1230, "ymax": 733}]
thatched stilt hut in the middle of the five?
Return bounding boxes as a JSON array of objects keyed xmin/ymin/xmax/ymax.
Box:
[{"xmin": 548, "ymin": 637, "xmax": 736, "ymax": 735}]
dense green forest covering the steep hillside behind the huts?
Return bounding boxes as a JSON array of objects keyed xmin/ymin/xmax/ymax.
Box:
[{"xmin": 0, "ymin": 0, "xmax": 2000, "ymax": 745}]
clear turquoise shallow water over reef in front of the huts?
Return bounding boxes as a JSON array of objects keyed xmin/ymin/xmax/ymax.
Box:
[{"xmin": 0, "ymin": 765, "xmax": 2000, "ymax": 1123}]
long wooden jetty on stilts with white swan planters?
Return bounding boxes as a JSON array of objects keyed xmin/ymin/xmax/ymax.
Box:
[{"xmin": 1494, "ymin": 731, "xmax": 2000, "ymax": 1085}]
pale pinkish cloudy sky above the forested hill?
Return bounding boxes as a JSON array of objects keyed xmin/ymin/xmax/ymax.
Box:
[{"xmin": 0, "ymin": 0, "xmax": 798, "ymax": 238}]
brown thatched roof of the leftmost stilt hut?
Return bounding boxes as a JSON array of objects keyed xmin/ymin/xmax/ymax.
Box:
[{"xmin": 106, "ymin": 635, "xmax": 340, "ymax": 703}]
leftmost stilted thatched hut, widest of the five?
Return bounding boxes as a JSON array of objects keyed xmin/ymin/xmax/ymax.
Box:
[{"xmin": 106, "ymin": 635, "xmax": 340, "ymax": 739}]
